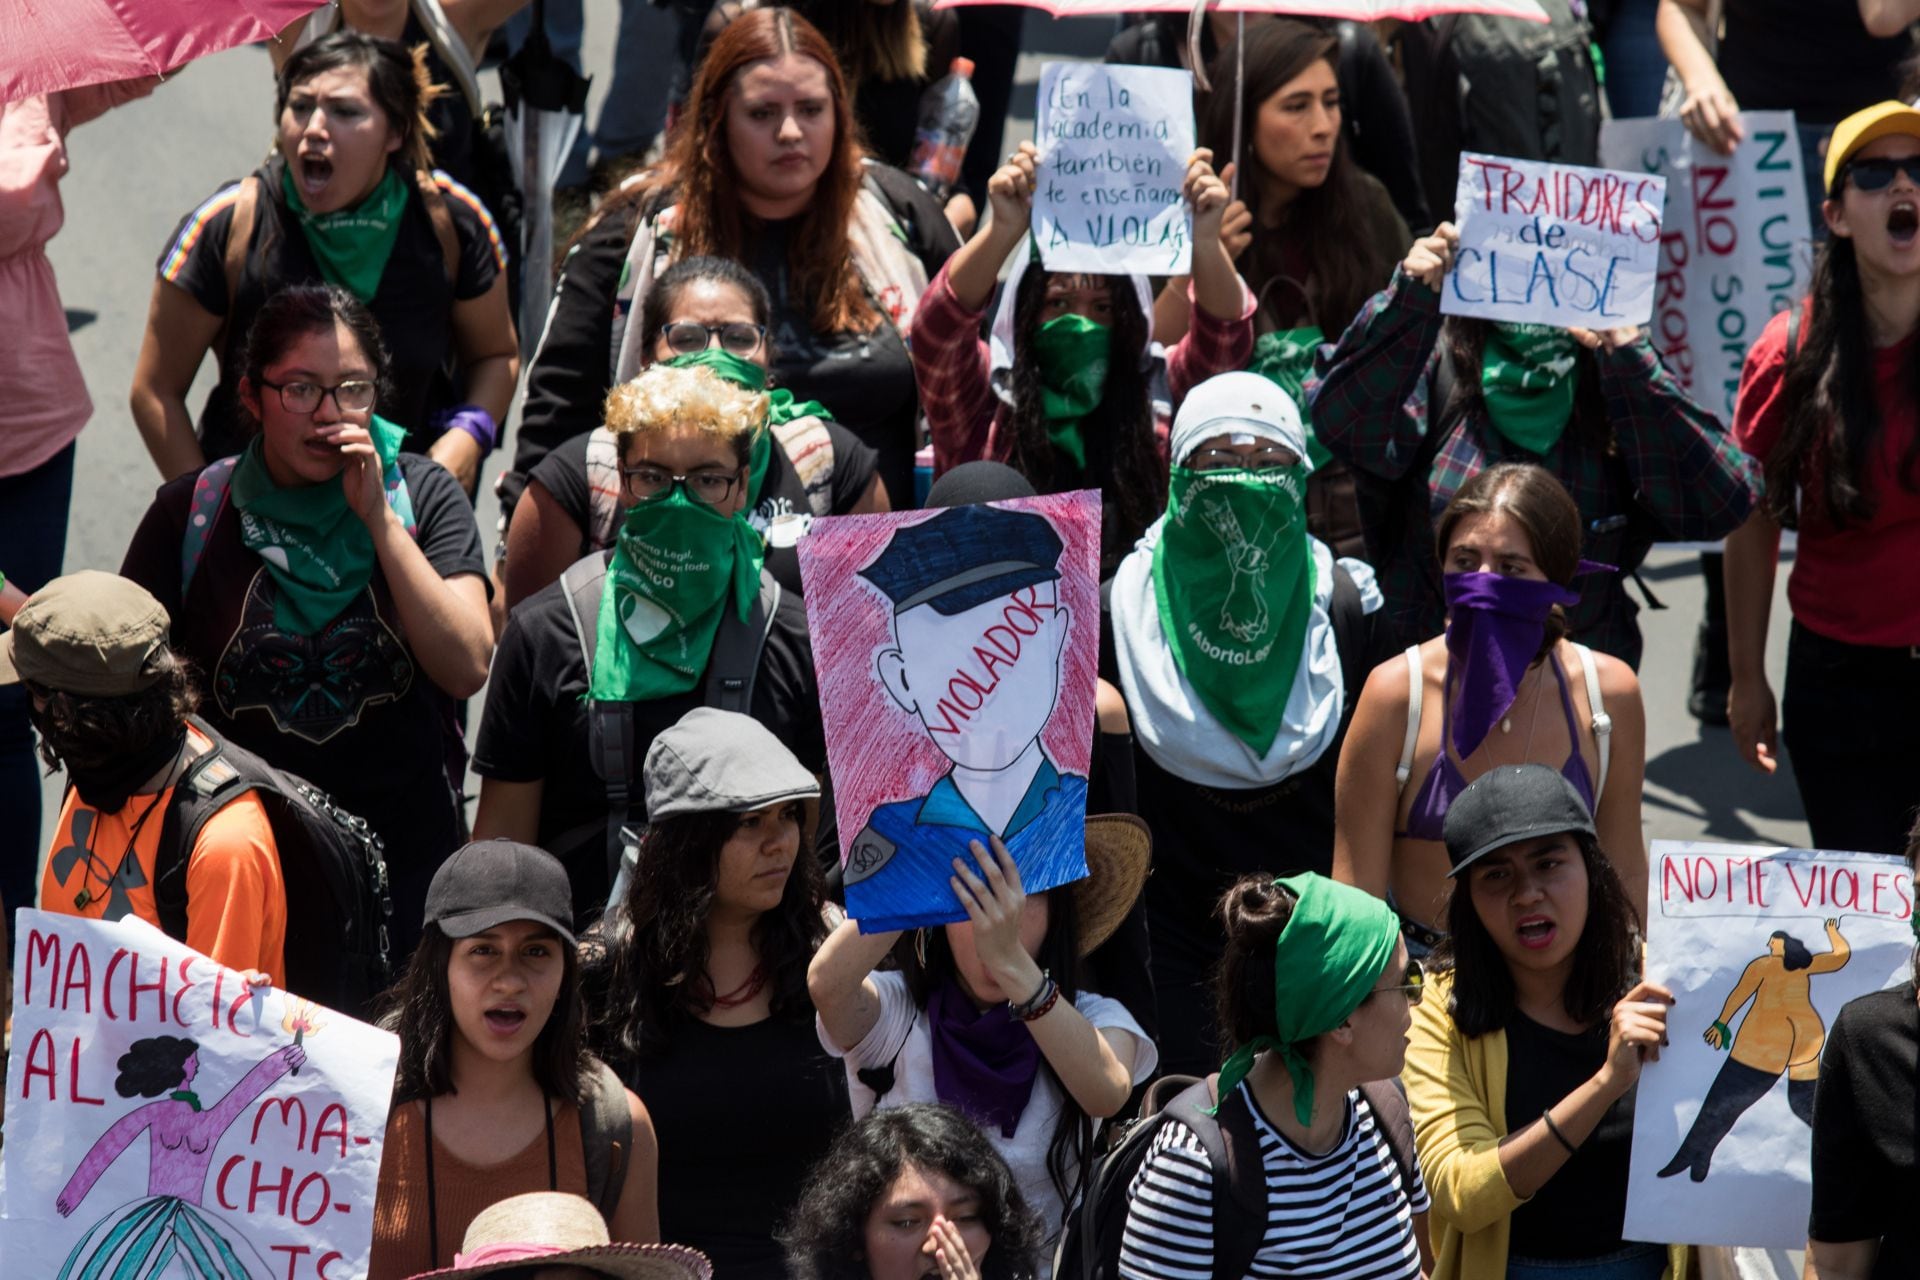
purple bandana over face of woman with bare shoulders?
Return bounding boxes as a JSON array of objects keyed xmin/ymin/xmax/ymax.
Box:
[{"xmin": 1446, "ymin": 574, "xmax": 1580, "ymax": 760}]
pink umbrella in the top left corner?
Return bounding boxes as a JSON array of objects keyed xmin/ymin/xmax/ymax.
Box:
[{"xmin": 0, "ymin": 0, "xmax": 321, "ymax": 102}]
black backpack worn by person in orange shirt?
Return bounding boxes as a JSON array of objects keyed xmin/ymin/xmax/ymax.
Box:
[{"xmin": 154, "ymin": 716, "xmax": 394, "ymax": 1019}]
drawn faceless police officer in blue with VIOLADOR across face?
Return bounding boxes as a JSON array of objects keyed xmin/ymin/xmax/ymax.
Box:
[{"xmin": 847, "ymin": 505, "xmax": 1087, "ymax": 931}]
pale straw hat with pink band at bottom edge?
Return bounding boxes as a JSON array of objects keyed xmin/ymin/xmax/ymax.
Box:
[{"xmin": 413, "ymin": 1192, "xmax": 714, "ymax": 1280}]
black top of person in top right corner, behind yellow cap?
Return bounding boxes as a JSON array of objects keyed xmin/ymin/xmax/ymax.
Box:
[{"xmin": 1718, "ymin": 0, "xmax": 1912, "ymax": 125}]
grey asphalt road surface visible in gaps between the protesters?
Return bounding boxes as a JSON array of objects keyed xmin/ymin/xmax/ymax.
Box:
[{"xmin": 30, "ymin": 0, "xmax": 1807, "ymax": 859}]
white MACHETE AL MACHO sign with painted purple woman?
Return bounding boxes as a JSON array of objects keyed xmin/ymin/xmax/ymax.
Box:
[{"xmin": 0, "ymin": 908, "xmax": 399, "ymax": 1280}]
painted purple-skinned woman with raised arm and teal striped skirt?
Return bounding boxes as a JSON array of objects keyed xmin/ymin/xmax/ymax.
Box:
[{"xmin": 54, "ymin": 1036, "xmax": 307, "ymax": 1280}]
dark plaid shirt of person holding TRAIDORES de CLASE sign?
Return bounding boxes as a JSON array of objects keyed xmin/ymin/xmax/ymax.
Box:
[{"xmin": 1306, "ymin": 269, "xmax": 1757, "ymax": 668}]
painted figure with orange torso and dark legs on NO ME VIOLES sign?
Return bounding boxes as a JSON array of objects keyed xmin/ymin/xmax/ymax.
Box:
[{"xmin": 1659, "ymin": 919, "xmax": 1853, "ymax": 1182}]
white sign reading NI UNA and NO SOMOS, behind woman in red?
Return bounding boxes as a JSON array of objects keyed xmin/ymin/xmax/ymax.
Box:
[{"xmin": 1599, "ymin": 111, "xmax": 1812, "ymax": 422}]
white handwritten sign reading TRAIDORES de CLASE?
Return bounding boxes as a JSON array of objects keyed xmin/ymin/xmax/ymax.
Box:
[{"xmin": 1440, "ymin": 152, "xmax": 1667, "ymax": 328}]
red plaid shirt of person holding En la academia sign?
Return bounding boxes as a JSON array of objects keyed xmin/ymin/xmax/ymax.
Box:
[{"xmin": 910, "ymin": 259, "xmax": 1254, "ymax": 476}]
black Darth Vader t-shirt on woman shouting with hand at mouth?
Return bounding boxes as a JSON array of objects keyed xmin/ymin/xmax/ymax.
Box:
[{"xmin": 121, "ymin": 455, "xmax": 488, "ymax": 898}]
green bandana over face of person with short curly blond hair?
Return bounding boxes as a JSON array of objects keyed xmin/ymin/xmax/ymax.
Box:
[{"xmin": 588, "ymin": 486, "xmax": 766, "ymax": 702}]
